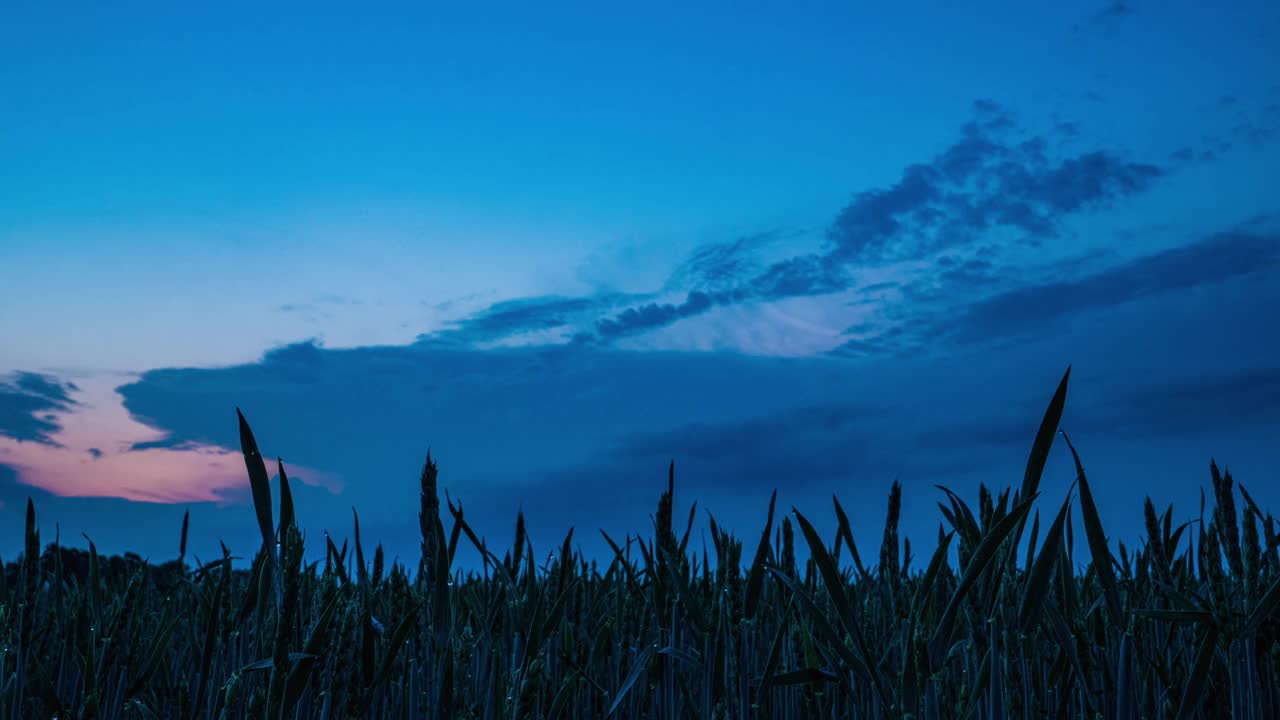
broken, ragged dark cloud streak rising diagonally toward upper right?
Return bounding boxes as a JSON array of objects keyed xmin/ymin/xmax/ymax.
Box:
[{"xmin": 422, "ymin": 99, "xmax": 1166, "ymax": 345}]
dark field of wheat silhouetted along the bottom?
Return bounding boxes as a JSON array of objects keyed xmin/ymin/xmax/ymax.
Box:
[{"xmin": 0, "ymin": 369, "xmax": 1280, "ymax": 720}]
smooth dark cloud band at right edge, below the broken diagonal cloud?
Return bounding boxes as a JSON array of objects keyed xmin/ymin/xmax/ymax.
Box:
[{"xmin": 831, "ymin": 219, "xmax": 1280, "ymax": 357}]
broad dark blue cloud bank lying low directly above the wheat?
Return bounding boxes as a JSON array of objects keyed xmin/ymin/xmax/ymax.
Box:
[{"xmin": 12, "ymin": 285, "xmax": 1280, "ymax": 571}]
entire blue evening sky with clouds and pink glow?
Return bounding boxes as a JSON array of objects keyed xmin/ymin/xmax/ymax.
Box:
[{"xmin": 0, "ymin": 1, "xmax": 1280, "ymax": 568}]
